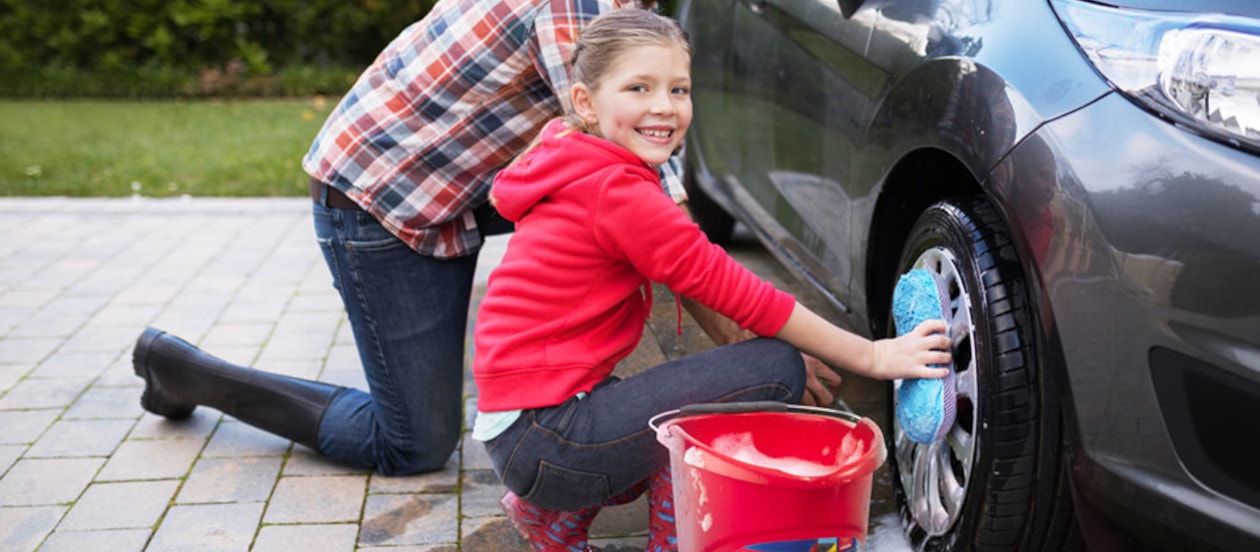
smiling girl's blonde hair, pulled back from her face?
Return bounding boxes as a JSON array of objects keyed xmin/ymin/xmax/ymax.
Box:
[{"xmin": 564, "ymin": 9, "xmax": 693, "ymax": 132}]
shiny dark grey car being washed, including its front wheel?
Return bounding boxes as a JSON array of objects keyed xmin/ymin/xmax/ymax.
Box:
[{"xmin": 679, "ymin": 0, "xmax": 1260, "ymax": 551}]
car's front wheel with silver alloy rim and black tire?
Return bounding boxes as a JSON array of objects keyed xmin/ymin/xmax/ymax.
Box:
[{"xmin": 888, "ymin": 198, "xmax": 1079, "ymax": 552}]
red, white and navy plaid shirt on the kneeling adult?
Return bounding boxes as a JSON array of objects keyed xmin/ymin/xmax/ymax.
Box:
[{"xmin": 302, "ymin": 0, "xmax": 687, "ymax": 258}]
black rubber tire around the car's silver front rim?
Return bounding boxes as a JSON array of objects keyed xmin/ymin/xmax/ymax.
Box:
[{"xmin": 898, "ymin": 198, "xmax": 1075, "ymax": 552}]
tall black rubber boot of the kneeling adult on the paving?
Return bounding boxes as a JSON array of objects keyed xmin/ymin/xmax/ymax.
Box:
[{"xmin": 131, "ymin": 328, "xmax": 344, "ymax": 451}]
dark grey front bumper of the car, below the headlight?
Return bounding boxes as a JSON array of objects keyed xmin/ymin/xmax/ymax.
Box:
[{"xmin": 1018, "ymin": 95, "xmax": 1260, "ymax": 549}]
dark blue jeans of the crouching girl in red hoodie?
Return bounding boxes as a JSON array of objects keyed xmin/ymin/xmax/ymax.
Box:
[{"xmin": 485, "ymin": 339, "xmax": 805, "ymax": 510}]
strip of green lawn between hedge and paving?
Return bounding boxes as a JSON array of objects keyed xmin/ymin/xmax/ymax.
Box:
[{"xmin": 0, "ymin": 98, "xmax": 333, "ymax": 197}]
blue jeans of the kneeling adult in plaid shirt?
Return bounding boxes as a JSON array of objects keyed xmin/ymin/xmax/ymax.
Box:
[{"xmin": 314, "ymin": 203, "xmax": 510, "ymax": 475}]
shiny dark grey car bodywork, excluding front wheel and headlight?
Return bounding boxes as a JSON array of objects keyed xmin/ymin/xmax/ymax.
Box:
[{"xmin": 680, "ymin": 0, "xmax": 1260, "ymax": 549}]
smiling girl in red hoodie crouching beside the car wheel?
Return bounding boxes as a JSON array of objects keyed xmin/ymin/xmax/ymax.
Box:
[{"xmin": 473, "ymin": 10, "xmax": 949, "ymax": 552}]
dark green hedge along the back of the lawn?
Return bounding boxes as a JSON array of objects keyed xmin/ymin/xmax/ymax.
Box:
[{"xmin": 0, "ymin": 0, "xmax": 436, "ymax": 97}]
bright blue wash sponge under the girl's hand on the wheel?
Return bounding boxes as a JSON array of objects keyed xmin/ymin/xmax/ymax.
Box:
[{"xmin": 892, "ymin": 268, "xmax": 956, "ymax": 445}]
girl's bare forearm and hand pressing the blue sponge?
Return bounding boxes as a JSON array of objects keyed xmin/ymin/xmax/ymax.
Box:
[{"xmin": 775, "ymin": 302, "xmax": 950, "ymax": 379}]
